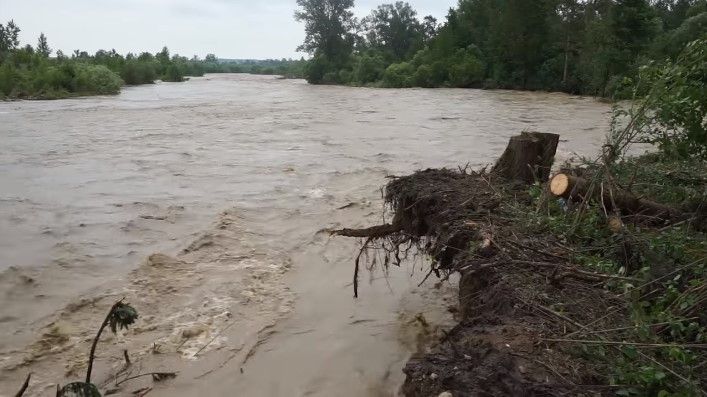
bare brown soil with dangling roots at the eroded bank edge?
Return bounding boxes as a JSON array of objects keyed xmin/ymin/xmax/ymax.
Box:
[{"xmin": 335, "ymin": 169, "xmax": 648, "ymax": 396}]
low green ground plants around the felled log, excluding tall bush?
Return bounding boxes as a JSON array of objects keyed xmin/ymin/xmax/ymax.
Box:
[{"xmin": 517, "ymin": 154, "xmax": 707, "ymax": 397}]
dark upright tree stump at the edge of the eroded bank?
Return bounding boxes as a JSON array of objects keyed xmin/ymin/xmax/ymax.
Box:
[{"xmin": 492, "ymin": 132, "xmax": 560, "ymax": 184}]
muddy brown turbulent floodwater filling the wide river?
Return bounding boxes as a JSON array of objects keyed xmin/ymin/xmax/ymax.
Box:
[{"xmin": 0, "ymin": 75, "xmax": 610, "ymax": 396}]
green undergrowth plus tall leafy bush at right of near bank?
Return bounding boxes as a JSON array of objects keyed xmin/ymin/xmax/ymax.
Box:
[{"xmin": 517, "ymin": 40, "xmax": 707, "ymax": 397}]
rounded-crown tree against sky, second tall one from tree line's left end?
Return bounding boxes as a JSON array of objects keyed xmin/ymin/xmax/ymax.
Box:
[{"xmin": 363, "ymin": 1, "xmax": 432, "ymax": 62}]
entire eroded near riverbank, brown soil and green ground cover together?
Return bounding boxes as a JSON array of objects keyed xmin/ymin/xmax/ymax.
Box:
[{"xmin": 339, "ymin": 134, "xmax": 707, "ymax": 396}]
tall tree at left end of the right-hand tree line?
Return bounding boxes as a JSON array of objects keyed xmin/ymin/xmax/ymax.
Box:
[{"xmin": 295, "ymin": 0, "xmax": 356, "ymax": 67}]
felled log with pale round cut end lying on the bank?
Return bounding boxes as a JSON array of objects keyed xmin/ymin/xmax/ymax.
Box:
[{"xmin": 550, "ymin": 173, "xmax": 685, "ymax": 221}]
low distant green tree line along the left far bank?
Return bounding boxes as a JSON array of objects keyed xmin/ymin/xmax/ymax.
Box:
[{"xmin": 0, "ymin": 20, "xmax": 305, "ymax": 99}]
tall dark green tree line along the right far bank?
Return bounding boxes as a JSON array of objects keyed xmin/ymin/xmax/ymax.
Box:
[{"xmin": 295, "ymin": 0, "xmax": 707, "ymax": 96}]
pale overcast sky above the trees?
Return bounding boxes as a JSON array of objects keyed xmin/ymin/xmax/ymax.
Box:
[{"xmin": 0, "ymin": 0, "xmax": 456, "ymax": 59}]
